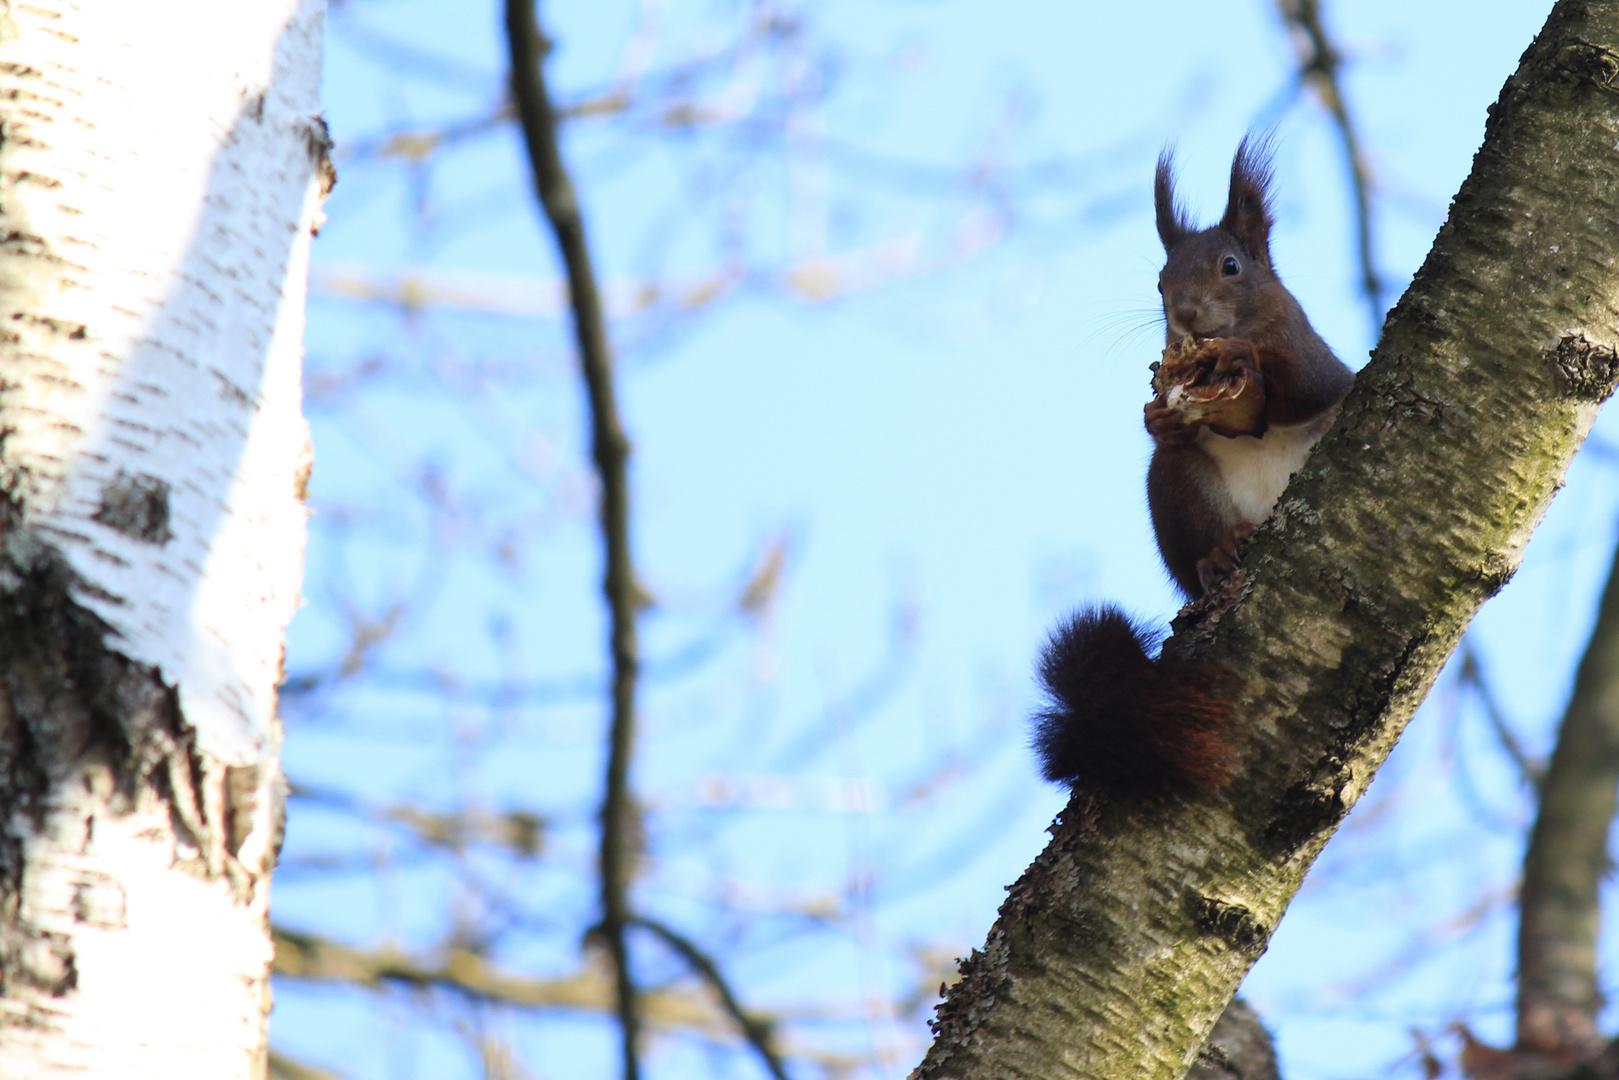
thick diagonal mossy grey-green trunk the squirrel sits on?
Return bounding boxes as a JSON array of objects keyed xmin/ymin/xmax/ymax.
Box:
[{"xmin": 915, "ymin": 0, "xmax": 1619, "ymax": 1080}]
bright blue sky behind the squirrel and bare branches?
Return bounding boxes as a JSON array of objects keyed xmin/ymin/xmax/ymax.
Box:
[{"xmin": 275, "ymin": 0, "xmax": 1614, "ymax": 1080}]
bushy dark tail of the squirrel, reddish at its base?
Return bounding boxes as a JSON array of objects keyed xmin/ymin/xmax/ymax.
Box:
[{"xmin": 1033, "ymin": 606, "xmax": 1232, "ymax": 795}]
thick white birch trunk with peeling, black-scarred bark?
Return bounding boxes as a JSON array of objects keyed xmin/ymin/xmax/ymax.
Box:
[{"xmin": 0, "ymin": 0, "xmax": 330, "ymax": 1080}]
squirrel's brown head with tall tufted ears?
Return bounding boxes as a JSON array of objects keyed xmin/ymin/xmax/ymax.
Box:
[{"xmin": 1153, "ymin": 136, "xmax": 1277, "ymax": 342}]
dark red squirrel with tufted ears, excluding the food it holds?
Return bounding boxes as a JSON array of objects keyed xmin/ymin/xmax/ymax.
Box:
[{"xmin": 1035, "ymin": 138, "xmax": 1355, "ymax": 793}]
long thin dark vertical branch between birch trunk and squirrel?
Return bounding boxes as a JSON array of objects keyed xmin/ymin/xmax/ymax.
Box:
[{"xmin": 505, "ymin": 0, "xmax": 640, "ymax": 1080}]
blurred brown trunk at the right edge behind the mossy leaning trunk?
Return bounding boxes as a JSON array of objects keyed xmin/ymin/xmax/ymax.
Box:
[{"xmin": 1517, "ymin": 540, "xmax": 1619, "ymax": 1057}]
